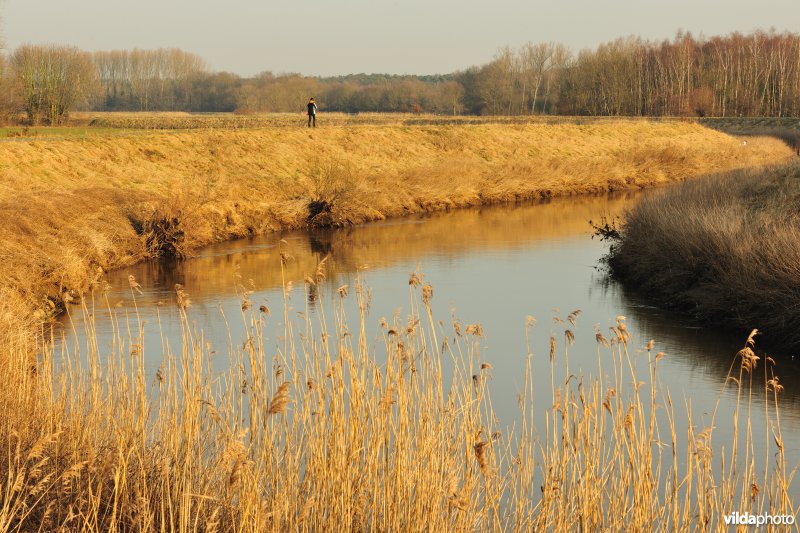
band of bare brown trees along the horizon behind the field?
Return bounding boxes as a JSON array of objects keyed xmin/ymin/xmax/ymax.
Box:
[{"xmin": 0, "ymin": 31, "xmax": 800, "ymax": 124}]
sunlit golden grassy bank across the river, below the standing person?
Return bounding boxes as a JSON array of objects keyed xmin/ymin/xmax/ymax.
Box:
[{"xmin": 0, "ymin": 121, "xmax": 791, "ymax": 330}]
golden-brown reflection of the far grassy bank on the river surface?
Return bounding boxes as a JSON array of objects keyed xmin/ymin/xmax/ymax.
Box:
[{"xmin": 98, "ymin": 193, "xmax": 636, "ymax": 307}]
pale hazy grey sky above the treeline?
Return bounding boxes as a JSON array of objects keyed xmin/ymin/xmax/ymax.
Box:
[{"xmin": 0, "ymin": 0, "xmax": 800, "ymax": 76}]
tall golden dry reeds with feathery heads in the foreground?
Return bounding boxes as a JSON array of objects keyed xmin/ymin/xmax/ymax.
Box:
[{"xmin": 0, "ymin": 272, "xmax": 795, "ymax": 531}]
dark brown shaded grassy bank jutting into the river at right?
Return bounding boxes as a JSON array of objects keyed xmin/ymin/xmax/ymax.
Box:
[{"xmin": 609, "ymin": 162, "xmax": 800, "ymax": 348}]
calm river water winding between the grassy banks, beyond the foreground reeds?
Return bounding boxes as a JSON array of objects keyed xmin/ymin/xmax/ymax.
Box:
[{"xmin": 57, "ymin": 192, "xmax": 800, "ymax": 492}]
